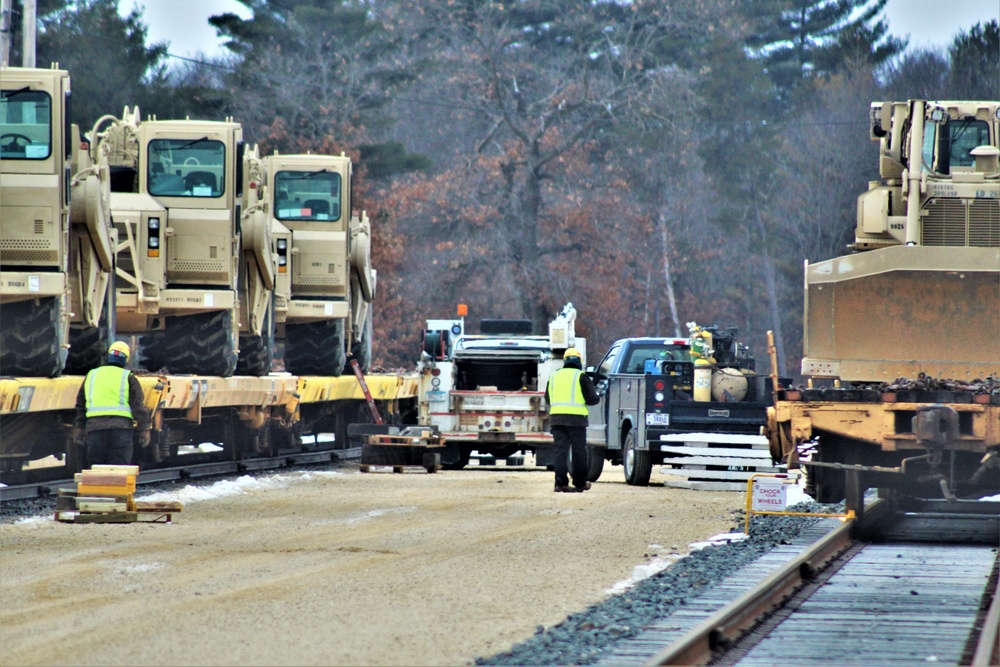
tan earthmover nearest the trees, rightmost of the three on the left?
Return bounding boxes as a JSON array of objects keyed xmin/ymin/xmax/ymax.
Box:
[{"xmin": 259, "ymin": 153, "xmax": 376, "ymax": 375}]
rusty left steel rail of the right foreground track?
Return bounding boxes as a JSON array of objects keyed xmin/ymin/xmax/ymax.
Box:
[{"xmin": 646, "ymin": 500, "xmax": 891, "ymax": 665}]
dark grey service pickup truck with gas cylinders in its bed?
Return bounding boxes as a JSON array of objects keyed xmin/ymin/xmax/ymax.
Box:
[{"xmin": 587, "ymin": 334, "xmax": 772, "ymax": 486}]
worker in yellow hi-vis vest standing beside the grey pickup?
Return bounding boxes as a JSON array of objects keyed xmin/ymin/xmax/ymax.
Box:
[{"xmin": 545, "ymin": 347, "xmax": 601, "ymax": 493}]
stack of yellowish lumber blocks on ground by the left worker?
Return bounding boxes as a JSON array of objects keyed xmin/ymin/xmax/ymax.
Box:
[{"xmin": 55, "ymin": 465, "xmax": 182, "ymax": 523}]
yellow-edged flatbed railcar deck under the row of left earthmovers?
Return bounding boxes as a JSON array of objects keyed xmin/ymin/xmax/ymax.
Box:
[{"xmin": 0, "ymin": 372, "xmax": 417, "ymax": 483}]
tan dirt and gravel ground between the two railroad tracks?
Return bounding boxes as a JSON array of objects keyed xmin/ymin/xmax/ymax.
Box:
[{"xmin": 0, "ymin": 467, "xmax": 744, "ymax": 665}]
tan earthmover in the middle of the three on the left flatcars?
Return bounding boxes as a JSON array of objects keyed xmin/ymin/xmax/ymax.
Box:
[{"xmin": 91, "ymin": 108, "xmax": 274, "ymax": 377}]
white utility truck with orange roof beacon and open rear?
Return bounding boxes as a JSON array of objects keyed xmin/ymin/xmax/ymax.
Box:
[{"xmin": 418, "ymin": 304, "xmax": 586, "ymax": 470}]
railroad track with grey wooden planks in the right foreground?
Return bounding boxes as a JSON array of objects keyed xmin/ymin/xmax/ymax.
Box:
[{"xmin": 601, "ymin": 500, "xmax": 1000, "ymax": 667}]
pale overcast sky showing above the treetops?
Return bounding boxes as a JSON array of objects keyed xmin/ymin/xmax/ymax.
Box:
[{"xmin": 127, "ymin": 0, "xmax": 1000, "ymax": 57}]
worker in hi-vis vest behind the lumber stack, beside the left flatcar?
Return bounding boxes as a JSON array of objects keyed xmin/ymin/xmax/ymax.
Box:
[{"xmin": 73, "ymin": 341, "xmax": 149, "ymax": 465}]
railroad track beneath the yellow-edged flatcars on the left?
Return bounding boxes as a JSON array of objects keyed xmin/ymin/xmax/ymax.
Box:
[{"xmin": 0, "ymin": 447, "xmax": 361, "ymax": 503}]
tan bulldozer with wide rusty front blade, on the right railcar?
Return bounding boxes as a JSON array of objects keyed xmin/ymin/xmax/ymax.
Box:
[{"xmin": 802, "ymin": 100, "xmax": 1000, "ymax": 382}]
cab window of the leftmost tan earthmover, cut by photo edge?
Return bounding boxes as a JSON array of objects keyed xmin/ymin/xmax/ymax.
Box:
[{"xmin": 0, "ymin": 88, "xmax": 52, "ymax": 160}]
